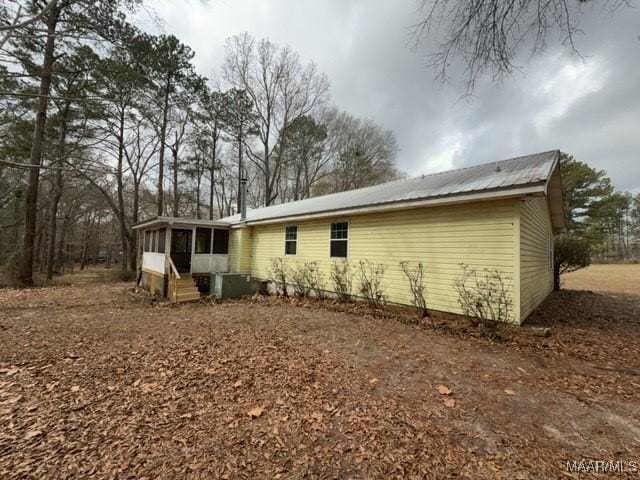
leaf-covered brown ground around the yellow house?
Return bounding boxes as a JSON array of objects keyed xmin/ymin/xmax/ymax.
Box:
[{"xmin": 0, "ymin": 265, "xmax": 640, "ymax": 479}]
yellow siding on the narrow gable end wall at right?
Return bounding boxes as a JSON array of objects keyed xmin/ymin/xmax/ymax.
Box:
[{"xmin": 520, "ymin": 197, "xmax": 553, "ymax": 319}]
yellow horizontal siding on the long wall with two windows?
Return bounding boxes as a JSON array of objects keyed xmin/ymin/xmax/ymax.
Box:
[{"xmin": 246, "ymin": 200, "xmax": 519, "ymax": 321}]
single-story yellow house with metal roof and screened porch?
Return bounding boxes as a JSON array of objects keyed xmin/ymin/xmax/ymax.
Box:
[{"xmin": 136, "ymin": 150, "xmax": 564, "ymax": 323}]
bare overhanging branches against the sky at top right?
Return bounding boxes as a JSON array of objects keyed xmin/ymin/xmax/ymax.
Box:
[{"xmin": 413, "ymin": 0, "xmax": 631, "ymax": 94}]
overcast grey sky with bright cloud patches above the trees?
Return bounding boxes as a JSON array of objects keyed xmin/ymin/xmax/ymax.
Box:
[{"xmin": 140, "ymin": 0, "xmax": 640, "ymax": 191}]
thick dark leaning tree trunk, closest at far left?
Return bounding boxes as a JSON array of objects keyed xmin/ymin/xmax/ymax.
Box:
[{"xmin": 19, "ymin": 6, "xmax": 60, "ymax": 285}]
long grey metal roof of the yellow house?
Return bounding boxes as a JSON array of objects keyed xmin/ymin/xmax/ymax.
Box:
[{"xmin": 220, "ymin": 150, "xmax": 559, "ymax": 224}]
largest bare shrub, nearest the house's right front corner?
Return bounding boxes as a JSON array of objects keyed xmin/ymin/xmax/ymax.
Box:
[{"xmin": 455, "ymin": 263, "xmax": 513, "ymax": 329}]
